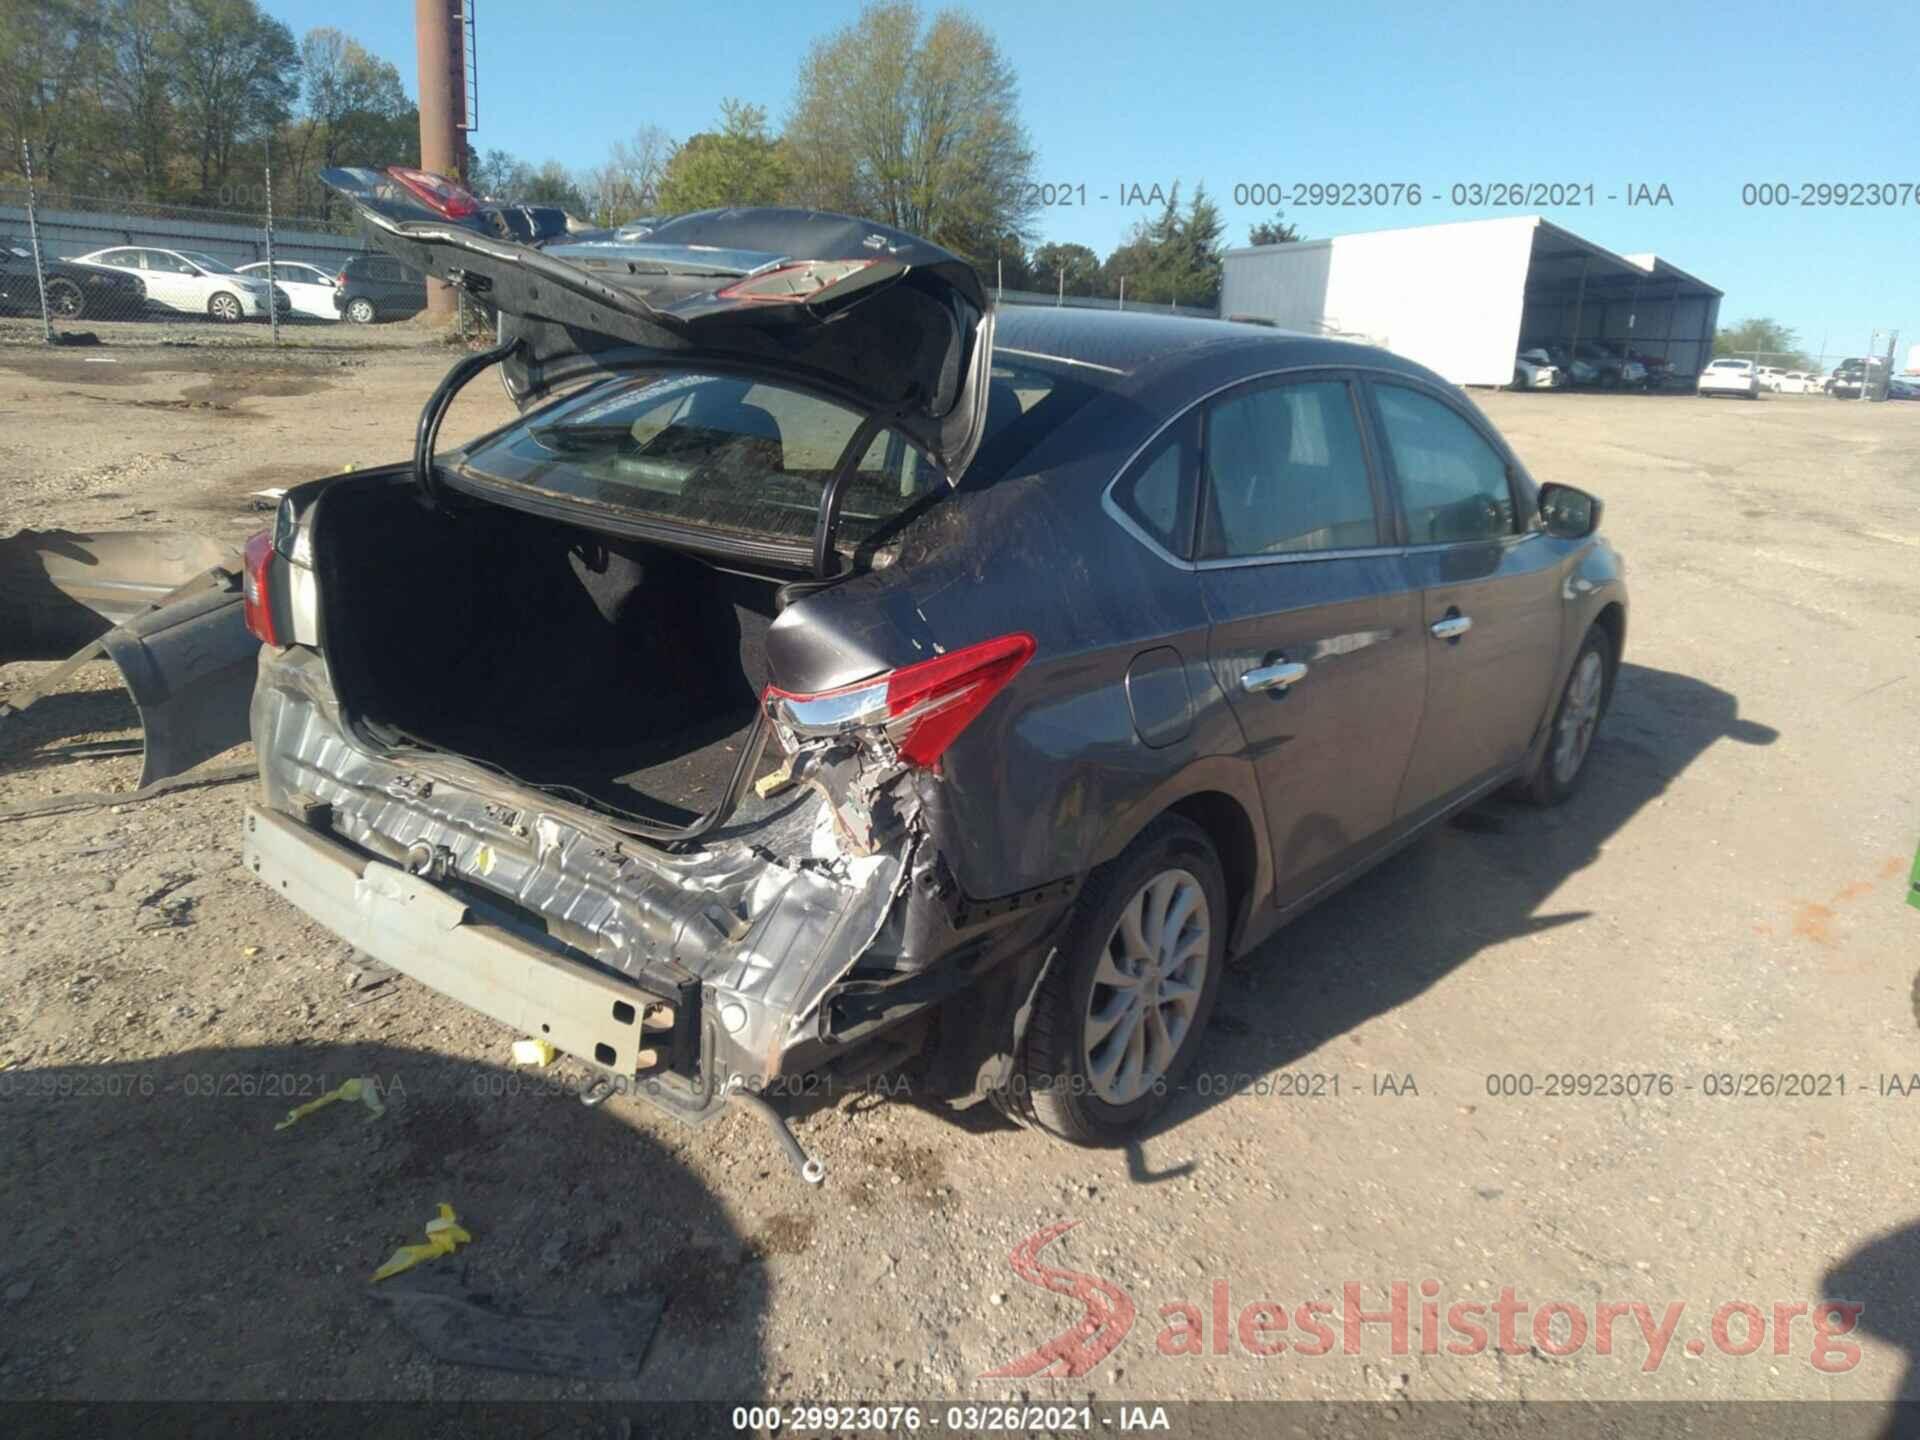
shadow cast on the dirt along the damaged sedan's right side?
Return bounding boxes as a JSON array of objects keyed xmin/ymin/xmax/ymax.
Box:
[{"xmin": 1154, "ymin": 664, "xmax": 1778, "ymax": 1133}]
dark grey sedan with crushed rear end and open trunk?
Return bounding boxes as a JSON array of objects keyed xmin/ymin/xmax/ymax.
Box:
[{"xmin": 244, "ymin": 171, "xmax": 1626, "ymax": 1140}]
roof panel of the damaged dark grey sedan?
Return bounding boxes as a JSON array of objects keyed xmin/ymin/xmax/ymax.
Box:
[{"xmin": 993, "ymin": 305, "xmax": 1434, "ymax": 380}]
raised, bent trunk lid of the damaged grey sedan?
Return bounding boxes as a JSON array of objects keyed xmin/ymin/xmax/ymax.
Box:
[{"xmin": 321, "ymin": 165, "xmax": 993, "ymax": 480}]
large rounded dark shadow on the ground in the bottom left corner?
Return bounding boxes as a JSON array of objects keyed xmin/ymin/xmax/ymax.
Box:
[{"xmin": 0, "ymin": 1044, "xmax": 764, "ymax": 1402}]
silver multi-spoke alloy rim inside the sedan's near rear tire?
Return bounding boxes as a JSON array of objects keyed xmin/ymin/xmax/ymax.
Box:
[{"xmin": 1081, "ymin": 870, "xmax": 1212, "ymax": 1106}]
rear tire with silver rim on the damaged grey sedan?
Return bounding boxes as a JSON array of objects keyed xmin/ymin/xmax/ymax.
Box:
[{"xmin": 1012, "ymin": 816, "xmax": 1233, "ymax": 1144}]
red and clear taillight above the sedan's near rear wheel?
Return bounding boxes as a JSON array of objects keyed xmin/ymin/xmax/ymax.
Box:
[{"xmin": 766, "ymin": 632, "xmax": 1033, "ymax": 768}]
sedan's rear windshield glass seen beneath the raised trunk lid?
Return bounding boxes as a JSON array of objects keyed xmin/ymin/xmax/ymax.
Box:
[{"xmin": 465, "ymin": 374, "xmax": 945, "ymax": 543}]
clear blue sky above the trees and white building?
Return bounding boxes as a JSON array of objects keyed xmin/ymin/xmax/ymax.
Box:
[{"xmin": 274, "ymin": 0, "xmax": 1920, "ymax": 355}]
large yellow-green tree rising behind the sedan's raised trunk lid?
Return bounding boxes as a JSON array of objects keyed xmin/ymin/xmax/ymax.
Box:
[{"xmin": 785, "ymin": 0, "xmax": 1035, "ymax": 259}]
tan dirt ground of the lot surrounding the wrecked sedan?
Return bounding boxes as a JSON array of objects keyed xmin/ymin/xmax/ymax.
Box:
[{"xmin": 0, "ymin": 314, "xmax": 1920, "ymax": 1402}]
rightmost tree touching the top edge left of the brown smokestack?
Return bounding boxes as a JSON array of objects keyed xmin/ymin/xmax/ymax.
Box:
[{"xmin": 175, "ymin": 0, "xmax": 300, "ymax": 200}]
